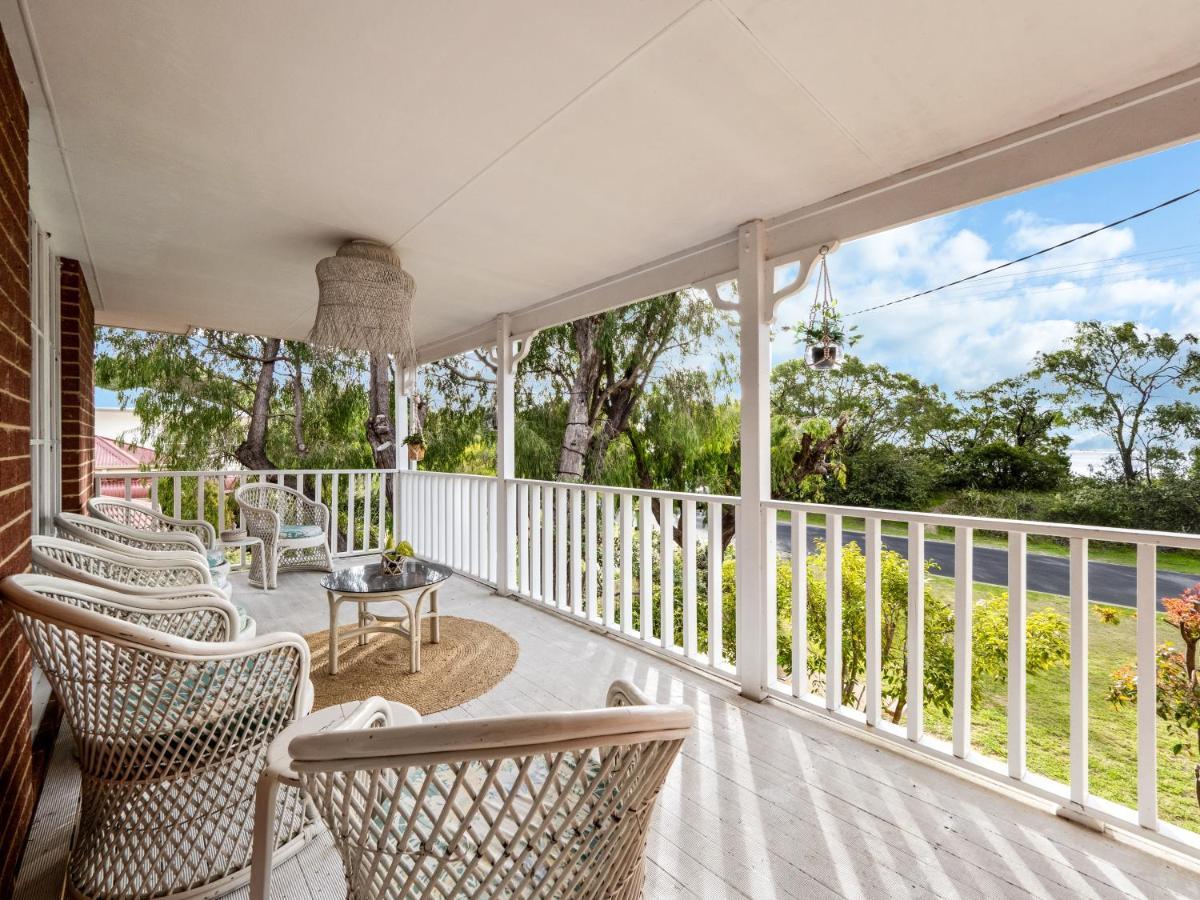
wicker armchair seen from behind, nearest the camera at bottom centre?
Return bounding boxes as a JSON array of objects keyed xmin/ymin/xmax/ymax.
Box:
[{"xmin": 267, "ymin": 682, "xmax": 695, "ymax": 900}]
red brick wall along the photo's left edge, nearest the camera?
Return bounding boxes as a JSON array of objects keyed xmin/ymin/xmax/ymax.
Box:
[{"xmin": 0, "ymin": 14, "xmax": 36, "ymax": 896}]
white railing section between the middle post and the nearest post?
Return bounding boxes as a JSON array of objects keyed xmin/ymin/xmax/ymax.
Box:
[{"xmin": 509, "ymin": 479, "xmax": 738, "ymax": 677}]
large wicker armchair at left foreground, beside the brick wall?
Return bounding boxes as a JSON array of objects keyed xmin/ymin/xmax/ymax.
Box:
[{"xmin": 0, "ymin": 578, "xmax": 312, "ymax": 900}]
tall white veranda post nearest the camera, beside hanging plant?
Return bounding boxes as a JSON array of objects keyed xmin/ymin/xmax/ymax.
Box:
[{"xmin": 734, "ymin": 221, "xmax": 774, "ymax": 700}]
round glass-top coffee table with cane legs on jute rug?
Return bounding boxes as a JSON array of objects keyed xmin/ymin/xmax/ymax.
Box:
[{"xmin": 320, "ymin": 559, "xmax": 454, "ymax": 674}]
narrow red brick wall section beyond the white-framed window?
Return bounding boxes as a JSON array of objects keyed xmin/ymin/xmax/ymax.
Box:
[{"xmin": 59, "ymin": 259, "xmax": 96, "ymax": 512}]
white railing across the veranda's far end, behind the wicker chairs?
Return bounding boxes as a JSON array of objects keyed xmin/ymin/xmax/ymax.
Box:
[{"xmin": 94, "ymin": 469, "xmax": 391, "ymax": 556}]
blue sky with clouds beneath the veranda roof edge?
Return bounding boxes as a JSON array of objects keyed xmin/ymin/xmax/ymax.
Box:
[{"xmin": 773, "ymin": 142, "xmax": 1200, "ymax": 460}]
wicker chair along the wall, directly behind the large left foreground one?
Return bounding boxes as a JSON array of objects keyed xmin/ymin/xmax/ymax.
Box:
[{"xmin": 31, "ymin": 535, "xmax": 257, "ymax": 638}]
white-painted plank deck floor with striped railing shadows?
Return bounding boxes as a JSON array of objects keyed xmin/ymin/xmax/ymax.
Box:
[{"xmin": 17, "ymin": 564, "xmax": 1200, "ymax": 900}]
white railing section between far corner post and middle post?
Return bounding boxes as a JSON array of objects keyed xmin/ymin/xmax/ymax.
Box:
[{"xmin": 397, "ymin": 470, "xmax": 496, "ymax": 586}]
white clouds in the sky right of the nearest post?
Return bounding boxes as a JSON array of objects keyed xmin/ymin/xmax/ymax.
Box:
[{"xmin": 775, "ymin": 211, "xmax": 1200, "ymax": 391}]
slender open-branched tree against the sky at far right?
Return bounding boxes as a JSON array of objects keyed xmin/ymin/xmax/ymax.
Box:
[{"xmin": 1032, "ymin": 322, "xmax": 1200, "ymax": 484}]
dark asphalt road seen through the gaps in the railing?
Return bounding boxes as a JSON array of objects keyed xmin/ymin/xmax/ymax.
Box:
[{"xmin": 776, "ymin": 522, "xmax": 1200, "ymax": 608}]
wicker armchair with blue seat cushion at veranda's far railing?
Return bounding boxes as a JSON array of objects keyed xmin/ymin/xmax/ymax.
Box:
[{"xmin": 234, "ymin": 481, "xmax": 334, "ymax": 589}]
